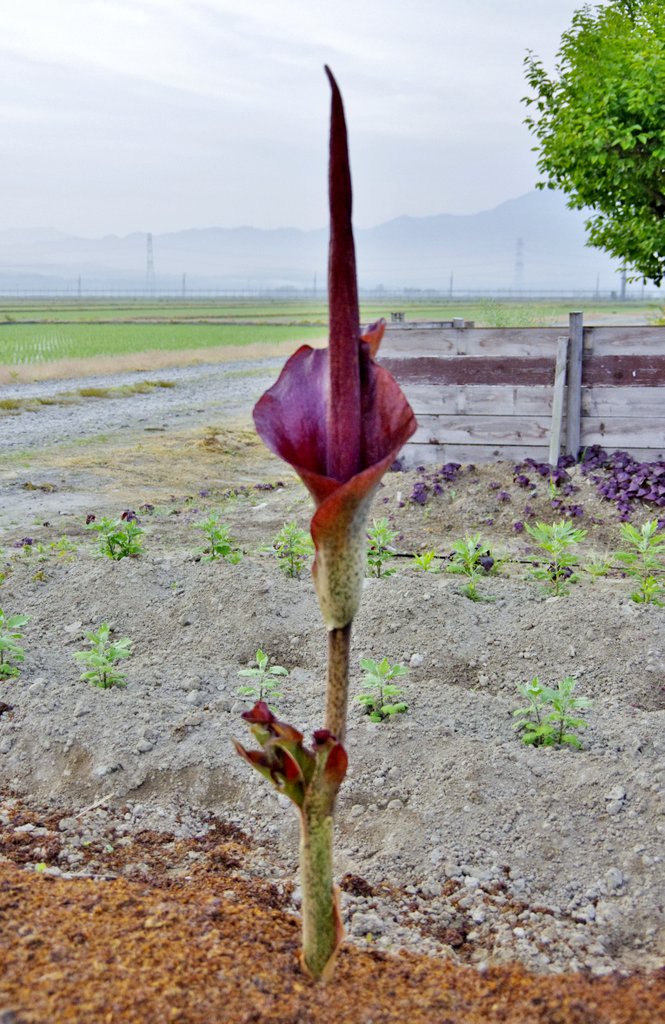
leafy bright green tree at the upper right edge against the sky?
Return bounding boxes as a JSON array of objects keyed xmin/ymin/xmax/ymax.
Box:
[{"xmin": 524, "ymin": 0, "xmax": 665, "ymax": 285}]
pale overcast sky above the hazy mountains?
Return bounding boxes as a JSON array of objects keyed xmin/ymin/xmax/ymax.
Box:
[{"xmin": 0, "ymin": 0, "xmax": 582, "ymax": 237}]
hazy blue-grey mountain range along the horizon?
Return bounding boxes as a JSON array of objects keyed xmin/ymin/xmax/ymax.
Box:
[{"xmin": 0, "ymin": 190, "xmax": 619, "ymax": 292}]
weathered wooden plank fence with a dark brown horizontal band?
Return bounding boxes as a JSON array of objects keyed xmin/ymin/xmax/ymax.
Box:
[{"xmin": 379, "ymin": 313, "xmax": 665, "ymax": 466}]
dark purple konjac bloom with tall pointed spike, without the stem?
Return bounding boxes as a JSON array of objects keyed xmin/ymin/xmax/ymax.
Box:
[{"xmin": 254, "ymin": 69, "xmax": 416, "ymax": 629}]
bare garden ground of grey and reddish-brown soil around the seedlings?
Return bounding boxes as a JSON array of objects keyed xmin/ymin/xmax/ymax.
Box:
[{"xmin": 0, "ymin": 356, "xmax": 665, "ymax": 1024}]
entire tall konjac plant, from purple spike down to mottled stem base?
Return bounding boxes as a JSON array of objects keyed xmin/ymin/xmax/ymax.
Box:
[{"xmin": 237, "ymin": 68, "xmax": 416, "ymax": 980}]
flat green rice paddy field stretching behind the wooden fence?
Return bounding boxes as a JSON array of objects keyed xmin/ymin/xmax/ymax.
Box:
[{"xmin": 0, "ymin": 297, "xmax": 662, "ymax": 368}]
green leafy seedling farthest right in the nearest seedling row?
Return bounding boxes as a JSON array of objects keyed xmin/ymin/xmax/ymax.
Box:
[{"xmin": 512, "ymin": 676, "xmax": 592, "ymax": 749}]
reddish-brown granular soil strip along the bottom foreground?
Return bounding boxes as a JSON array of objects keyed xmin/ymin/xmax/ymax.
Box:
[{"xmin": 0, "ymin": 806, "xmax": 665, "ymax": 1024}]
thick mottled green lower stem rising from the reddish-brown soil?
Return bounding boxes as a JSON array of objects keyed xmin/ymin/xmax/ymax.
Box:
[{"xmin": 300, "ymin": 775, "xmax": 343, "ymax": 981}]
